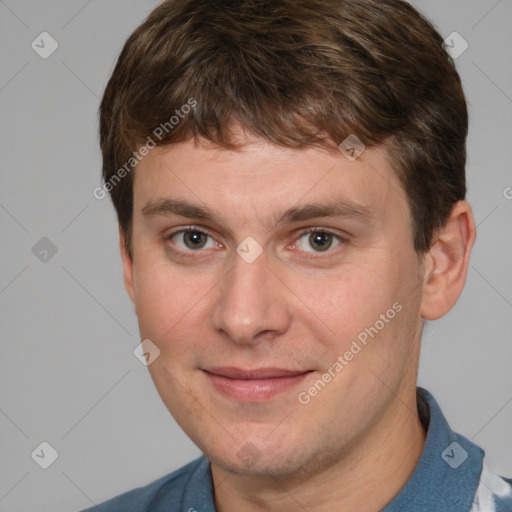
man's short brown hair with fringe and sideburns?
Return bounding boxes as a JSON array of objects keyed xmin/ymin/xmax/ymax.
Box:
[{"xmin": 100, "ymin": 0, "xmax": 468, "ymax": 253}]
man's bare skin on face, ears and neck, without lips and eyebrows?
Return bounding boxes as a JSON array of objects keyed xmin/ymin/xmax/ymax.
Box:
[{"xmin": 120, "ymin": 131, "xmax": 475, "ymax": 512}]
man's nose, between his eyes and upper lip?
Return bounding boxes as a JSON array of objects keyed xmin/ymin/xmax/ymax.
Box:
[{"xmin": 211, "ymin": 253, "xmax": 291, "ymax": 344}]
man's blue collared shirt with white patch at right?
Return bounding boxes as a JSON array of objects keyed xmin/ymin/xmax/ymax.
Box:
[{"xmin": 84, "ymin": 388, "xmax": 512, "ymax": 512}]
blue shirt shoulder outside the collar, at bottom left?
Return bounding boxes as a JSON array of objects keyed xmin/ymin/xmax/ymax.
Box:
[{"xmin": 82, "ymin": 456, "xmax": 206, "ymax": 512}]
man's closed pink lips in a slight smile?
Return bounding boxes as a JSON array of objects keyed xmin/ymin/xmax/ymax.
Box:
[{"xmin": 203, "ymin": 367, "xmax": 313, "ymax": 402}]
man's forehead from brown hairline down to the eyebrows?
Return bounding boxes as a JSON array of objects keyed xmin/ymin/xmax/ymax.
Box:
[{"xmin": 134, "ymin": 140, "xmax": 404, "ymax": 231}]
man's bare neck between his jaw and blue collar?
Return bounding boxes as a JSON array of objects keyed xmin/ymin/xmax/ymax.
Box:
[{"xmin": 212, "ymin": 388, "xmax": 426, "ymax": 512}]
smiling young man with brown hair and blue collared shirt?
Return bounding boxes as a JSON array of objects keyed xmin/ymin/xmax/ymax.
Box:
[{"xmin": 86, "ymin": 0, "xmax": 512, "ymax": 512}]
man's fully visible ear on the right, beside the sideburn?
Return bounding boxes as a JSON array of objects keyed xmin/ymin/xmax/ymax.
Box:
[{"xmin": 420, "ymin": 201, "xmax": 476, "ymax": 320}]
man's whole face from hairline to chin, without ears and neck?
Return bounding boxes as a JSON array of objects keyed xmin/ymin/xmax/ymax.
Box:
[{"xmin": 124, "ymin": 134, "xmax": 424, "ymax": 475}]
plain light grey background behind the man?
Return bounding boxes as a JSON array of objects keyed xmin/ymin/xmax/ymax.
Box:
[{"xmin": 0, "ymin": 0, "xmax": 512, "ymax": 512}]
